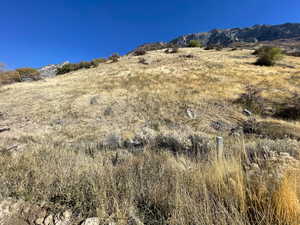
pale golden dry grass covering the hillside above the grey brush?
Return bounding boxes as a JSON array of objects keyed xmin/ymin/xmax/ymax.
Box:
[{"xmin": 0, "ymin": 48, "xmax": 300, "ymax": 150}]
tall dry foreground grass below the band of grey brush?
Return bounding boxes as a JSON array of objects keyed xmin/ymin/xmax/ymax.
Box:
[{"xmin": 0, "ymin": 144, "xmax": 300, "ymax": 225}]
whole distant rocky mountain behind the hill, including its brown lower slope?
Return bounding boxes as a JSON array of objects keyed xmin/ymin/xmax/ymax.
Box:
[{"xmin": 133, "ymin": 23, "xmax": 300, "ymax": 52}]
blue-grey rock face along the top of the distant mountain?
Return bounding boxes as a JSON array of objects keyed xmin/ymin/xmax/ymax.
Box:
[{"xmin": 170, "ymin": 23, "xmax": 300, "ymax": 47}]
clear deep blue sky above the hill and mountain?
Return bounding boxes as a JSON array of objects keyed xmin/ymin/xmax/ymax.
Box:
[{"xmin": 0, "ymin": 0, "xmax": 300, "ymax": 68}]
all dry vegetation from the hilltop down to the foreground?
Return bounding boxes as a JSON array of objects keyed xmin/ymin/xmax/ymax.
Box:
[{"xmin": 0, "ymin": 48, "xmax": 300, "ymax": 225}]
